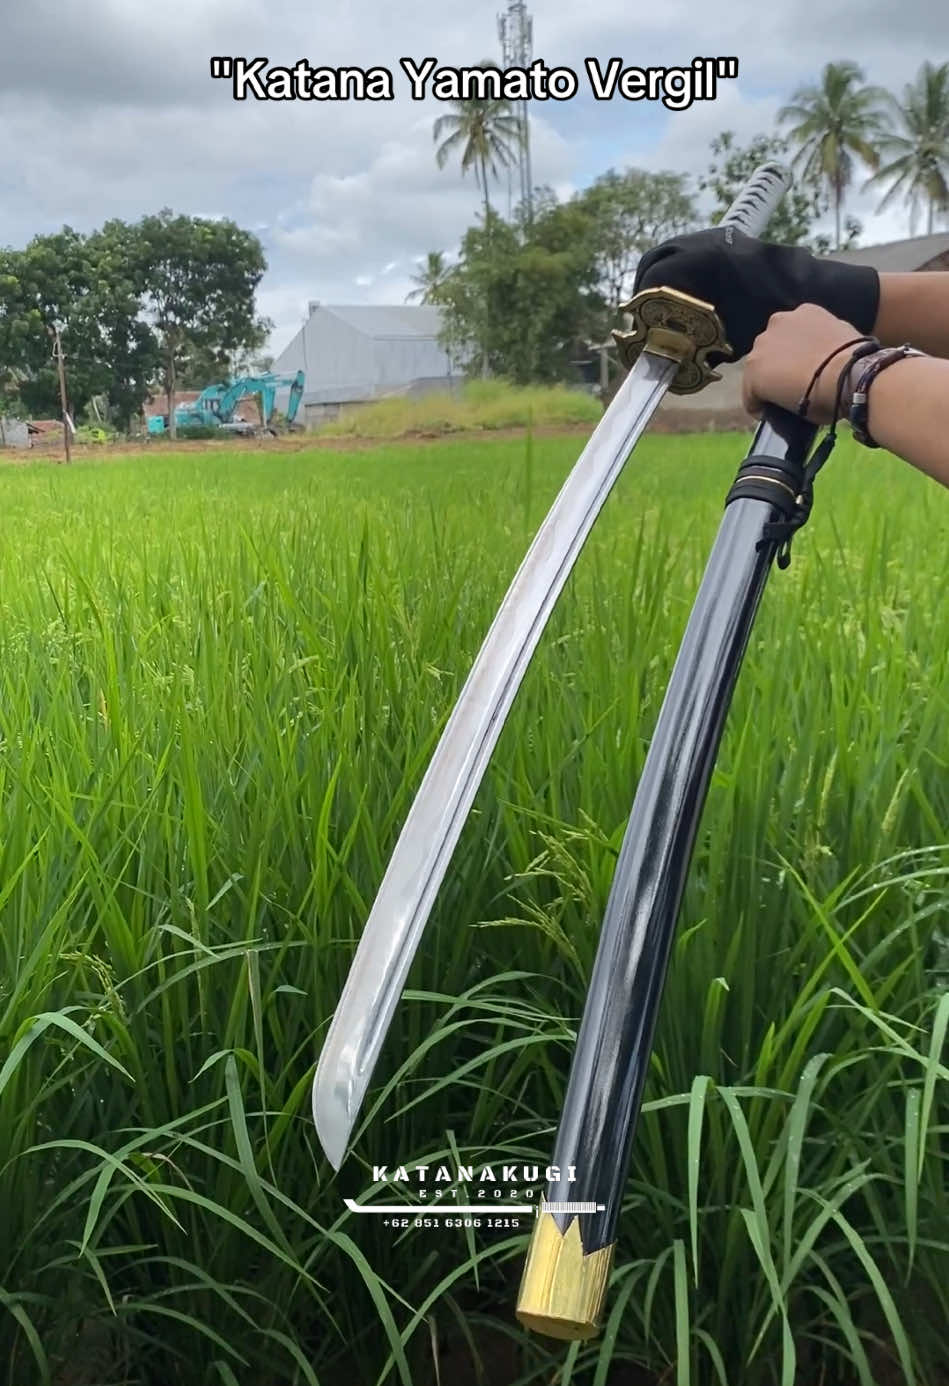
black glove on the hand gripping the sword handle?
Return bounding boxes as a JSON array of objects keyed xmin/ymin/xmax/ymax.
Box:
[{"xmin": 633, "ymin": 226, "xmax": 880, "ymax": 365}]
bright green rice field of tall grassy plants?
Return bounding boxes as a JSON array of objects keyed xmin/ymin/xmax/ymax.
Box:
[{"xmin": 0, "ymin": 435, "xmax": 949, "ymax": 1386}]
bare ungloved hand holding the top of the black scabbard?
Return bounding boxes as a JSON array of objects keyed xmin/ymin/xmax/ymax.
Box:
[{"xmin": 743, "ymin": 304, "xmax": 860, "ymax": 424}]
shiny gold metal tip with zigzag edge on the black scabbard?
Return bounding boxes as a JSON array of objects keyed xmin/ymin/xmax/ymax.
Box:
[{"xmin": 517, "ymin": 1211, "xmax": 614, "ymax": 1340}]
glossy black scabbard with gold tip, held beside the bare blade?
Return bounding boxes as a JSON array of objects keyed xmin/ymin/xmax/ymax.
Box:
[{"xmin": 517, "ymin": 410, "xmax": 816, "ymax": 1339}]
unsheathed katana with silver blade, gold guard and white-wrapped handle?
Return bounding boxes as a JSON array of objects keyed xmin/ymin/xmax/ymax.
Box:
[{"xmin": 307, "ymin": 164, "xmax": 787, "ymax": 1168}]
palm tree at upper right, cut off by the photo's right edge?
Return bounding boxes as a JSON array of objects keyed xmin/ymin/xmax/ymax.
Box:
[{"xmin": 864, "ymin": 62, "xmax": 949, "ymax": 236}]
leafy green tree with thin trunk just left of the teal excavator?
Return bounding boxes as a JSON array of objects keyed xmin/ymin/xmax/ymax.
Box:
[{"xmin": 134, "ymin": 208, "xmax": 266, "ymax": 437}]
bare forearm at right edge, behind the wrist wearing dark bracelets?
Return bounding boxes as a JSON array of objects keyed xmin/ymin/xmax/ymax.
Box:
[{"xmin": 867, "ymin": 357, "xmax": 949, "ymax": 486}]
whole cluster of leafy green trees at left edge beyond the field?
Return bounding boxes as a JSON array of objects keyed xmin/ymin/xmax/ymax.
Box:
[{"xmin": 0, "ymin": 211, "xmax": 270, "ymax": 426}]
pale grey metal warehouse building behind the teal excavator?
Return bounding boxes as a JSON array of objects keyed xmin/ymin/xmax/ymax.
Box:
[{"xmin": 273, "ymin": 302, "xmax": 459, "ymax": 424}]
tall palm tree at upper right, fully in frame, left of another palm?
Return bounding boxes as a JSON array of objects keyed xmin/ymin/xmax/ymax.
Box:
[{"xmin": 777, "ymin": 61, "xmax": 891, "ymax": 249}]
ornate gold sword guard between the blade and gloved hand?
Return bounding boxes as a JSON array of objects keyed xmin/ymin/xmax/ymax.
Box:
[{"xmin": 612, "ymin": 288, "xmax": 733, "ymax": 395}]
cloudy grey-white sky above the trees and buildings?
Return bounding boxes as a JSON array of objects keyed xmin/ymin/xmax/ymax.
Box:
[{"xmin": 0, "ymin": 0, "xmax": 949, "ymax": 352}]
